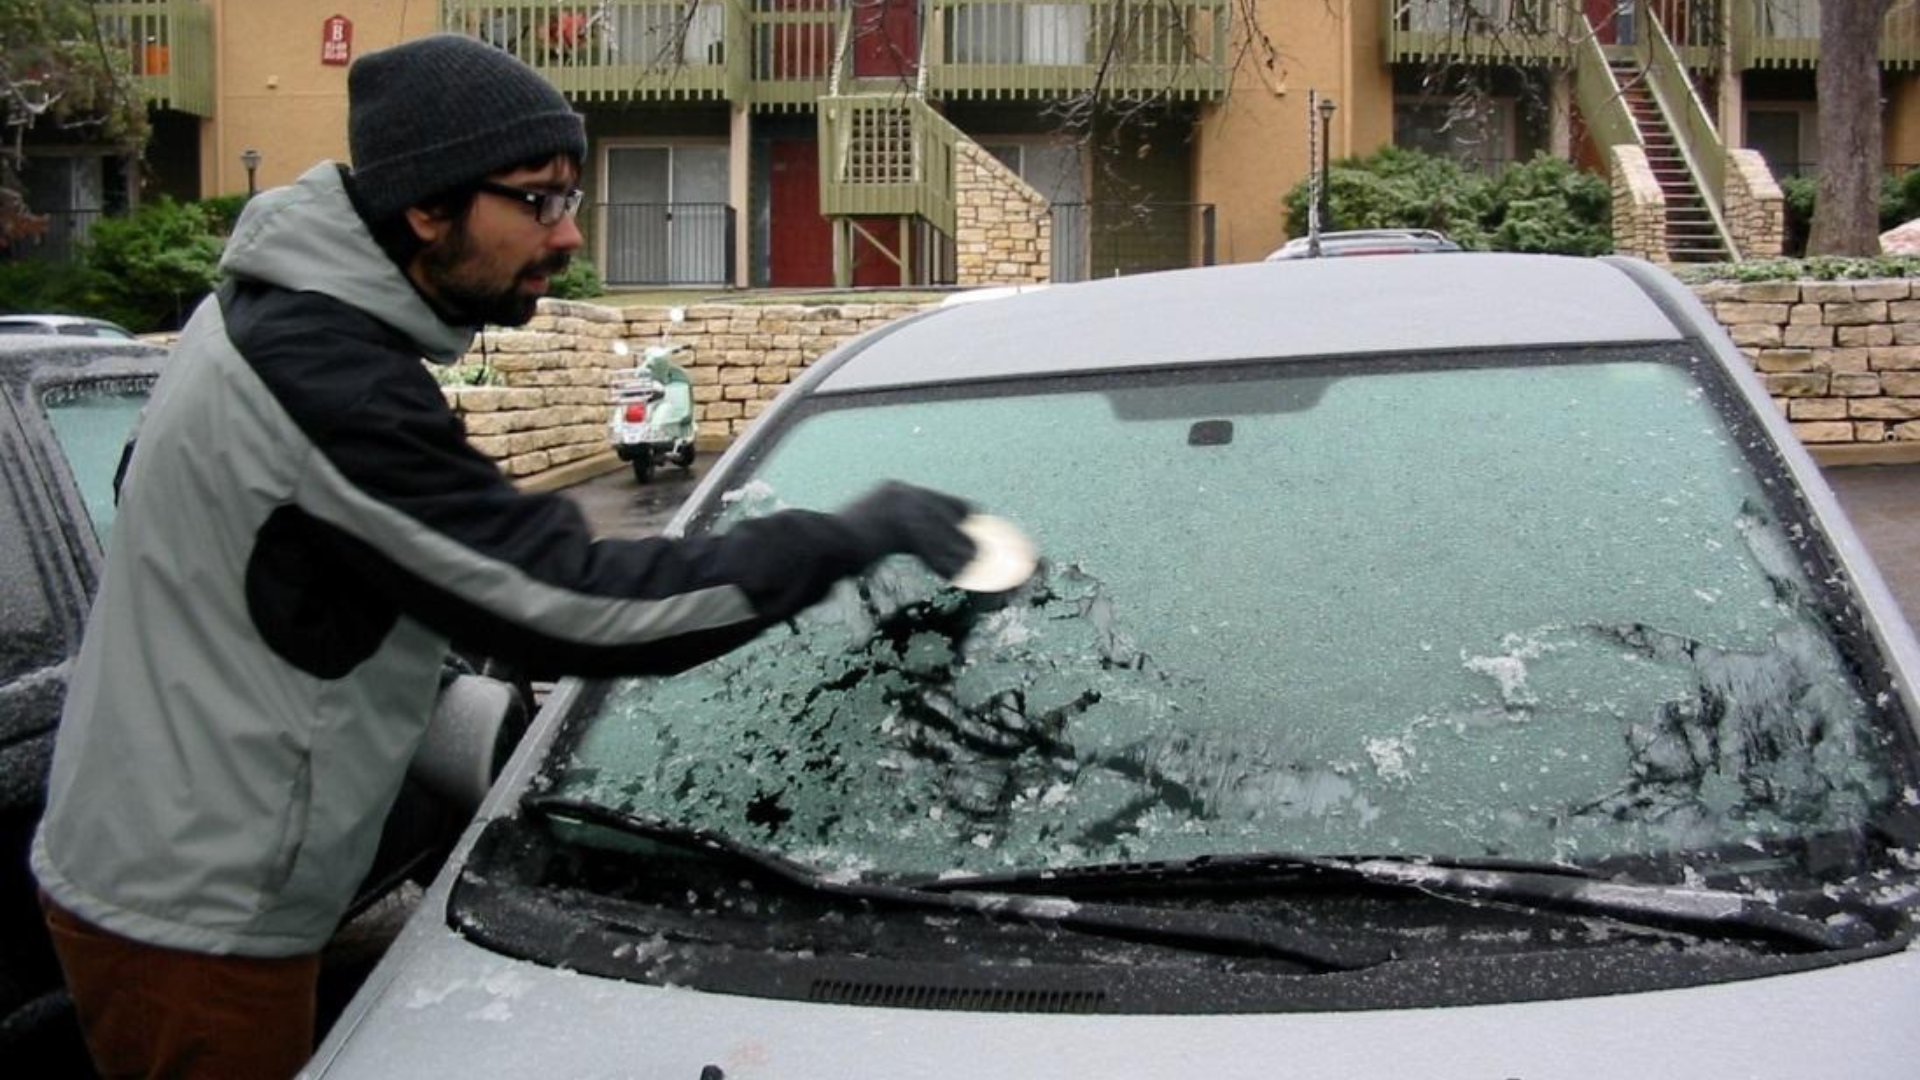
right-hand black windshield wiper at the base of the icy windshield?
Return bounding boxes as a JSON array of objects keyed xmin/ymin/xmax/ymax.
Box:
[{"xmin": 914, "ymin": 853, "xmax": 1882, "ymax": 951}]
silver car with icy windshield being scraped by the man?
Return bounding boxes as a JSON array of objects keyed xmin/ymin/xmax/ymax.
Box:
[{"xmin": 307, "ymin": 254, "xmax": 1920, "ymax": 1080}]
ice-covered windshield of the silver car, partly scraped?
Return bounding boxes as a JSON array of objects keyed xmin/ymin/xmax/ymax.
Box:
[{"xmin": 555, "ymin": 354, "xmax": 1895, "ymax": 874}]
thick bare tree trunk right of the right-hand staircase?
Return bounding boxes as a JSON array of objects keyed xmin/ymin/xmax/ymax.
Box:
[{"xmin": 1807, "ymin": 0, "xmax": 1893, "ymax": 256}]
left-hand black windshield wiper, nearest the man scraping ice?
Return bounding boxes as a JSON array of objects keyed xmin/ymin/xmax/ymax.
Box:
[{"xmin": 520, "ymin": 796, "xmax": 1392, "ymax": 970}]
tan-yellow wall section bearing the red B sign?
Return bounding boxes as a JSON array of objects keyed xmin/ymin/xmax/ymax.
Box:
[{"xmin": 200, "ymin": 0, "xmax": 440, "ymax": 196}]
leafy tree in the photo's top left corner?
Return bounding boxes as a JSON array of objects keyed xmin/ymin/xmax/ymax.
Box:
[{"xmin": 0, "ymin": 0, "xmax": 148, "ymax": 248}]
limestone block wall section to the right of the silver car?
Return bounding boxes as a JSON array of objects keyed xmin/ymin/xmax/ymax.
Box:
[{"xmin": 1695, "ymin": 279, "xmax": 1920, "ymax": 446}]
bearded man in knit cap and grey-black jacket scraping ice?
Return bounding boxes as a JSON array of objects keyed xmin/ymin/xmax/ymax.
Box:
[{"xmin": 33, "ymin": 37, "xmax": 973, "ymax": 1078}]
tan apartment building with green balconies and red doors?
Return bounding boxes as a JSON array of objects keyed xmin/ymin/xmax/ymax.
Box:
[{"xmin": 15, "ymin": 0, "xmax": 1920, "ymax": 276}]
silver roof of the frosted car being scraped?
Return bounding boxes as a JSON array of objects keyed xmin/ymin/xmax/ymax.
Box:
[{"xmin": 812, "ymin": 252, "xmax": 1686, "ymax": 394}]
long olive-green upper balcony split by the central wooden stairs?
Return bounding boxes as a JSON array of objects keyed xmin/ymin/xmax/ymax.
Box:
[{"xmin": 445, "ymin": 0, "xmax": 1231, "ymax": 110}]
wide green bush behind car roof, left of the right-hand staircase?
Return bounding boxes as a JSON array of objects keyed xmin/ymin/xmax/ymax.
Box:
[{"xmin": 1286, "ymin": 146, "xmax": 1613, "ymax": 256}]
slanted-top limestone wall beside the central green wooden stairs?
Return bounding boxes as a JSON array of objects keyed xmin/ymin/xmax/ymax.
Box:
[{"xmin": 954, "ymin": 140, "xmax": 1054, "ymax": 284}]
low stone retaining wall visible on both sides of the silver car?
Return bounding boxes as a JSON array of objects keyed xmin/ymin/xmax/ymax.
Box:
[{"xmin": 447, "ymin": 281, "xmax": 1920, "ymax": 477}]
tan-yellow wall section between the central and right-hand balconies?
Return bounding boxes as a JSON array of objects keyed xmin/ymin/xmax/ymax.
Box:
[{"xmin": 1194, "ymin": 0, "xmax": 1394, "ymax": 263}]
